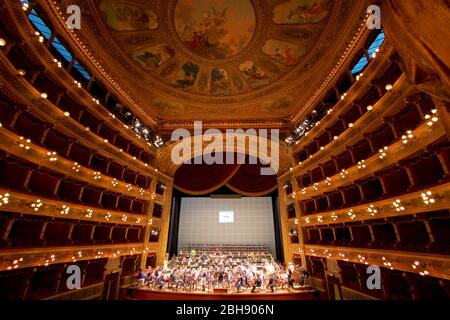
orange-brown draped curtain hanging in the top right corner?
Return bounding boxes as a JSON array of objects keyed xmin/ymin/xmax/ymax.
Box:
[{"xmin": 381, "ymin": 0, "xmax": 450, "ymax": 101}]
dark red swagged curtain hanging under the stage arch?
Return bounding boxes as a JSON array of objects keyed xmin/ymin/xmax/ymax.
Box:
[{"xmin": 174, "ymin": 152, "xmax": 277, "ymax": 196}]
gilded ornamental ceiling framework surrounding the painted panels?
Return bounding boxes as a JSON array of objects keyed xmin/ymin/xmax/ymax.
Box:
[{"xmin": 26, "ymin": 0, "xmax": 368, "ymax": 125}]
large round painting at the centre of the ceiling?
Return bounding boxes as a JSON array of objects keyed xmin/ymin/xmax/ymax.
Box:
[{"xmin": 174, "ymin": 0, "xmax": 256, "ymax": 59}]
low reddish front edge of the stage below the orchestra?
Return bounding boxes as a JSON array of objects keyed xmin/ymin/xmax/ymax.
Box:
[{"xmin": 128, "ymin": 287, "xmax": 318, "ymax": 300}]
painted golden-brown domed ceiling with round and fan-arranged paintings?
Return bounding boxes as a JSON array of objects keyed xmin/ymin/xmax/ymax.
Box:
[{"xmin": 75, "ymin": 0, "xmax": 365, "ymax": 122}]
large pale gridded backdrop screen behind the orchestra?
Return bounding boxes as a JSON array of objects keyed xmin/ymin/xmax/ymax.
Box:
[{"xmin": 178, "ymin": 197, "xmax": 275, "ymax": 255}]
